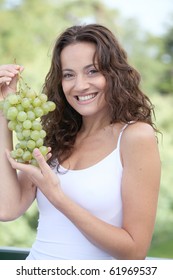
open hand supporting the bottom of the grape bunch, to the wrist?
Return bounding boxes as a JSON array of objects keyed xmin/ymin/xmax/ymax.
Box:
[{"xmin": 6, "ymin": 148, "xmax": 61, "ymax": 202}]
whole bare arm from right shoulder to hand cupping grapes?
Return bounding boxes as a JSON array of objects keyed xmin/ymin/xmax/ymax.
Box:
[{"xmin": 6, "ymin": 123, "xmax": 160, "ymax": 259}]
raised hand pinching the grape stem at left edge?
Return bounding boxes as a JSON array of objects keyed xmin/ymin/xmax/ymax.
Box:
[{"xmin": 0, "ymin": 64, "xmax": 24, "ymax": 100}]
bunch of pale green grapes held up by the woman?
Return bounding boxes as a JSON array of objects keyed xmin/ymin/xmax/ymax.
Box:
[{"xmin": 0, "ymin": 77, "xmax": 56, "ymax": 166}]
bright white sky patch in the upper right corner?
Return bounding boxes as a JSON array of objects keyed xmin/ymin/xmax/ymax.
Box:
[{"xmin": 103, "ymin": 0, "xmax": 173, "ymax": 34}]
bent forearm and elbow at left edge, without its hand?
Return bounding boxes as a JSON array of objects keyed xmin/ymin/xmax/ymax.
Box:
[{"xmin": 0, "ymin": 111, "xmax": 35, "ymax": 221}]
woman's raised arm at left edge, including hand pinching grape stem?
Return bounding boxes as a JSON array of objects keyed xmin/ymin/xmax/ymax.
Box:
[{"xmin": 0, "ymin": 64, "xmax": 35, "ymax": 221}]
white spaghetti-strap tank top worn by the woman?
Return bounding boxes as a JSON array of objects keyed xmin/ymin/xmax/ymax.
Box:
[{"xmin": 27, "ymin": 126, "xmax": 126, "ymax": 260}]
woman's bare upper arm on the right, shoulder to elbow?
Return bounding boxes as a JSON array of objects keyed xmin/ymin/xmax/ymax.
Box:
[{"xmin": 121, "ymin": 122, "xmax": 161, "ymax": 258}]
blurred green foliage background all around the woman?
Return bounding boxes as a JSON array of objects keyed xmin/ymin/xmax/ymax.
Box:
[{"xmin": 0, "ymin": 0, "xmax": 173, "ymax": 258}]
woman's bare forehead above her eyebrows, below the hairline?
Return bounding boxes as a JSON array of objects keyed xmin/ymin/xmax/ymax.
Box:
[{"xmin": 60, "ymin": 42, "xmax": 96, "ymax": 68}]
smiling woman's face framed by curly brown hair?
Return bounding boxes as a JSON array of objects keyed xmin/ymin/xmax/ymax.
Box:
[{"xmin": 61, "ymin": 42, "xmax": 108, "ymax": 117}]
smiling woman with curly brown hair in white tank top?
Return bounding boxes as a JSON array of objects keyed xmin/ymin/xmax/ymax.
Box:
[{"xmin": 0, "ymin": 24, "xmax": 160, "ymax": 259}]
